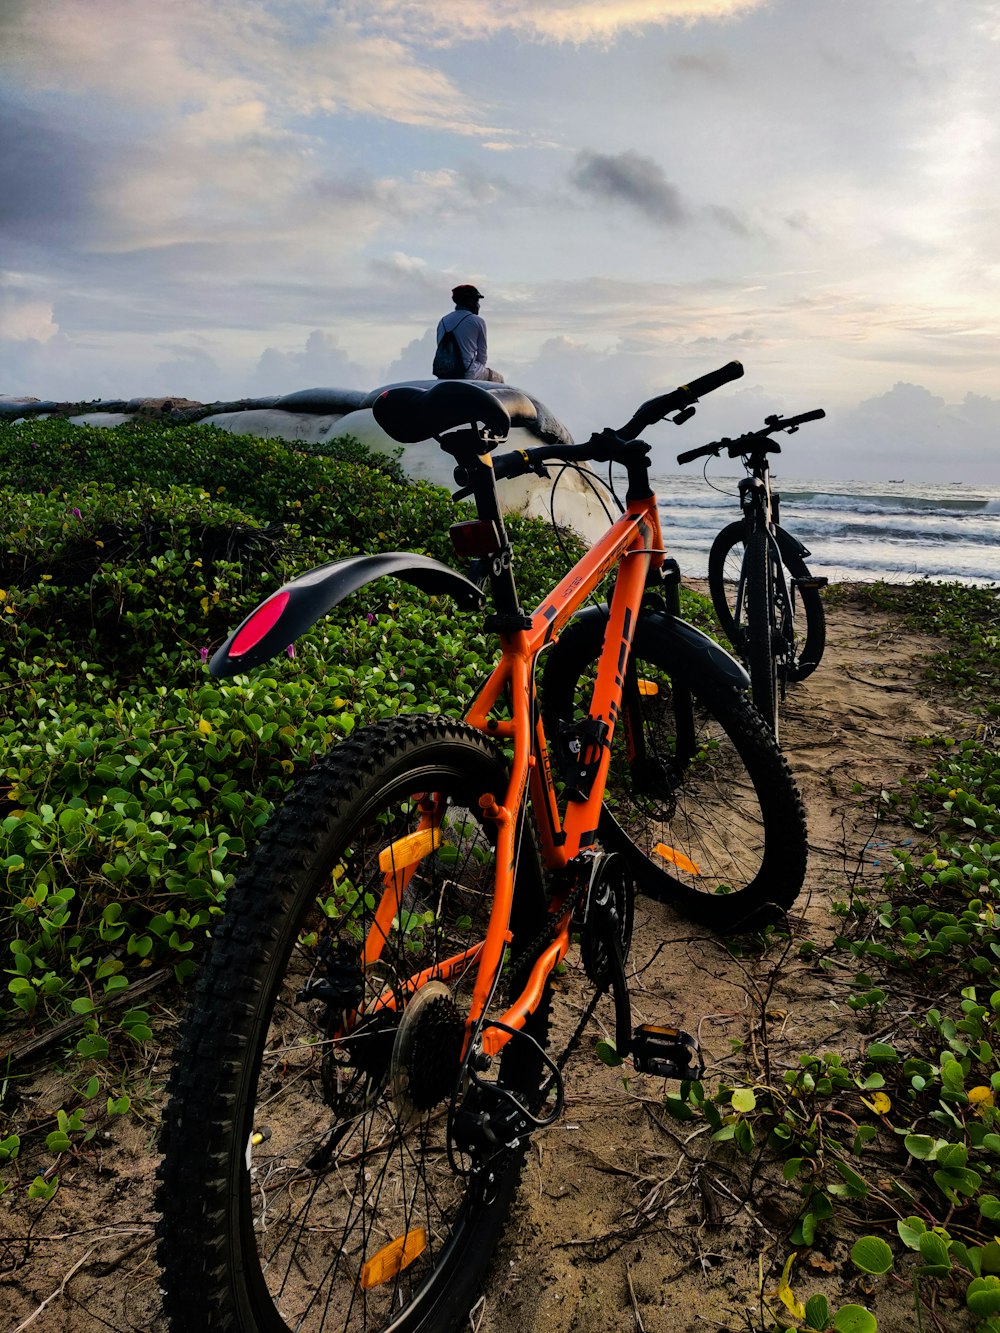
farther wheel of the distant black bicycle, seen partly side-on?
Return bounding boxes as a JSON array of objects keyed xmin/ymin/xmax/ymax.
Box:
[{"xmin": 708, "ymin": 521, "xmax": 827, "ymax": 681}]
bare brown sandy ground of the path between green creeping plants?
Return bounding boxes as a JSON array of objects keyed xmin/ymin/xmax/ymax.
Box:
[{"xmin": 0, "ymin": 601, "xmax": 964, "ymax": 1333}]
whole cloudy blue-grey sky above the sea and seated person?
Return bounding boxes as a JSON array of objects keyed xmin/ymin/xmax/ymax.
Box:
[{"xmin": 0, "ymin": 0, "xmax": 1000, "ymax": 484}]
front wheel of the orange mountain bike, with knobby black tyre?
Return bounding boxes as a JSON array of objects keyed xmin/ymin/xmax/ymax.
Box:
[{"xmin": 541, "ymin": 613, "xmax": 807, "ymax": 933}]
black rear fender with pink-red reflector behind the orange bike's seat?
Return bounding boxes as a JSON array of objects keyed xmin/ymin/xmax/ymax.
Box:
[{"xmin": 208, "ymin": 551, "xmax": 485, "ymax": 676}]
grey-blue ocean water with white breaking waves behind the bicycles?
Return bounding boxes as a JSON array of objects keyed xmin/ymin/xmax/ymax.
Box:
[{"xmin": 653, "ymin": 472, "xmax": 1000, "ymax": 584}]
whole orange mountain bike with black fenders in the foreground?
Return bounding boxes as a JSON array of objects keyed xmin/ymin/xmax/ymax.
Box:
[{"xmin": 157, "ymin": 363, "xmax": 805, "ymax": 1333}]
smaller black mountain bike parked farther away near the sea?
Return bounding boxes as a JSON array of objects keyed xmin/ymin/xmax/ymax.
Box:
[{"xmin": 677, "ymin": 408, "xmax": 827, "ymax": 734}]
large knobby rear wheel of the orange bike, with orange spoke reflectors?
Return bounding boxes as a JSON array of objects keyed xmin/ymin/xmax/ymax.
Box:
[{"xmin": 157, "ymin": 717, "xmax": 548, "ymax": 1333}]
